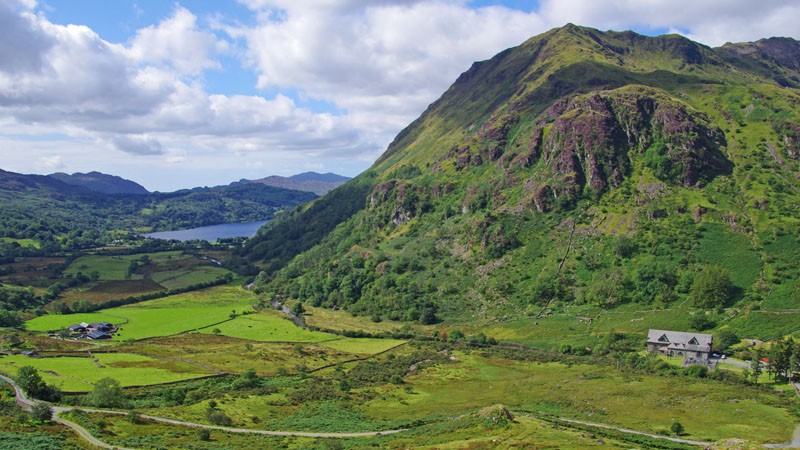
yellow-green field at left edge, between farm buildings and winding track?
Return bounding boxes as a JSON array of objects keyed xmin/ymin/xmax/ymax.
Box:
[{"xmin": 0, "ymin": 353, "xmax": 212, "ymax": 392}]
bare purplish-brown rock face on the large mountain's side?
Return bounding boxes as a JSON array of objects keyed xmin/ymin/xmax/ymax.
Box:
[{"xmin": 529, "ymin": 89, "xmax": 733, "ymax": 206}]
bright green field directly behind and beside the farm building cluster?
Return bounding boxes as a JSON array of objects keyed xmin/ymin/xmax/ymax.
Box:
[{"xmin": 25, "ymin": 286, "xmax": 256, "ymax": 340}]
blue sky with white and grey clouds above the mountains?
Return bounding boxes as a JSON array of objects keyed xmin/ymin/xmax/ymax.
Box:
[{"xmin": 0, "ymin": 0, "xmax": 800, "ymax": 192}]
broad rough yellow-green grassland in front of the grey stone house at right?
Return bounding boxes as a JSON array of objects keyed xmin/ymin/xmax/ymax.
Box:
[{"xmin": 364, "ymin": 355, "xmax": 795, "ymax": 442}]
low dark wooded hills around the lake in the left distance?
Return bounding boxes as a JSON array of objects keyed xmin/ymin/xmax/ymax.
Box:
[{"xmin": 0, "ymin": 170, "xmax": 317, "ymax": 252}]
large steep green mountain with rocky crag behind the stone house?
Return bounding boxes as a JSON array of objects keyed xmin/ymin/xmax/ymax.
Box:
[{"xmin": 240, "ymin": 25, "xmax": 800, "ymax": 337}]
